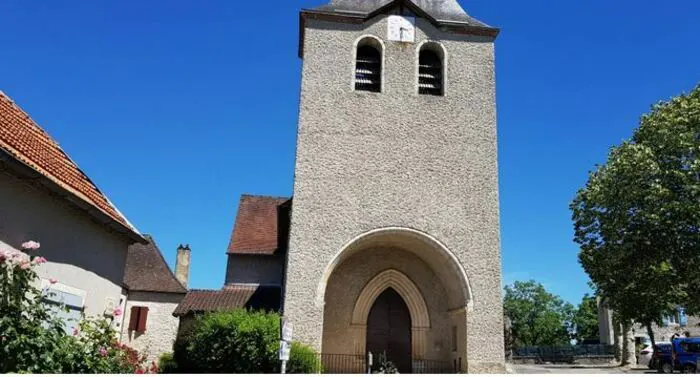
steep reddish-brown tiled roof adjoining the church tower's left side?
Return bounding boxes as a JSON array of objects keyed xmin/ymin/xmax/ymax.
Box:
[{"xmin": 228, "ymin": 195, "xmax": 290, "ymax": 254}]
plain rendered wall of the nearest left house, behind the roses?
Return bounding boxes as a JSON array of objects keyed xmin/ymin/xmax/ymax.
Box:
[{"xmin": 0, "ymin": 169, "xmax": 131, "ymax": 326}]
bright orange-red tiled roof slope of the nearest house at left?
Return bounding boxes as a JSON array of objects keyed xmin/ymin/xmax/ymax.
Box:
[{"xmin": 0, "ymin": 91, "xmax": 135, "ymax": 231}]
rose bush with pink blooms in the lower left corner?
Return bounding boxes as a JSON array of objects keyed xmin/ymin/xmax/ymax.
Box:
[{"xmin": 0, "ymin": 241, "xmax": 158, "ymax": 374}]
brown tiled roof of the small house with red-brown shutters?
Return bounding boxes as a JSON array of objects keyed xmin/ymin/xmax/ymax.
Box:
[{"xmin": 124, "ymin": 235, "xmax": 187, "ymax": 293}]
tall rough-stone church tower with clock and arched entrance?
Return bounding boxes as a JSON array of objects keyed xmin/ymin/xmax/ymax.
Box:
[{"xmin": 283, "ymin": 0, "xmax": 504, "ymax": 372}]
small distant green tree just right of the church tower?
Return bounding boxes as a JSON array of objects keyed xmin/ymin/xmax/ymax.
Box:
[{"xmin": 503, "ymin": 280, "xmax": 574, "ymax": 347}]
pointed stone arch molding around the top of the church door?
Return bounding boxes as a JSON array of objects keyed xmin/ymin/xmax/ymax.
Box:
[{"xmin": 352, "ymin": 269, "xmax": 430, "ymax": 329}]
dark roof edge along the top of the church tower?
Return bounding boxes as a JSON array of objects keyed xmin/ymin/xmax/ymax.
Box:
[{"xmin": 299, "ymin": 7, "xmax": 501, "ymax": 59}]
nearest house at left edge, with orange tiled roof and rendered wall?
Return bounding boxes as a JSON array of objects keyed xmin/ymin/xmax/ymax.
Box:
[{"xmin": 0, "ymin": 92, "xmax": 146, "ymax": 331}]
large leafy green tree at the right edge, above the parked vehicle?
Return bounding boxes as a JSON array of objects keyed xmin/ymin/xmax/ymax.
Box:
[{"xmin": 571, "ymin": 87, "xmax": 700, "ymax": 343}]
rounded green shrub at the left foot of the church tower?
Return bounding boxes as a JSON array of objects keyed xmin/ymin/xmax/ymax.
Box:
[{"xmin": 175, "ymin": 309, "xmax": 280, "ymax": 373}]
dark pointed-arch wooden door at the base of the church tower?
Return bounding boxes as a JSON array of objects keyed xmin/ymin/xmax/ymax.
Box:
[{"xmin": 366, "ymin": 288, "xmax": 412, "ymax": 373}]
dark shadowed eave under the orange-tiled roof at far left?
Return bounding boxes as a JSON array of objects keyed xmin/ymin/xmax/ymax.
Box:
[{"xmin": 0, "ymin": 149, "xmax": 148, "ymax": 244}]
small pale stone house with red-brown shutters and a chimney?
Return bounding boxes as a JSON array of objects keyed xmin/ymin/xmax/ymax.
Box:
[{"xmin": 121, "ymin": 235, "xmax": 191, "ymax": 360}]
